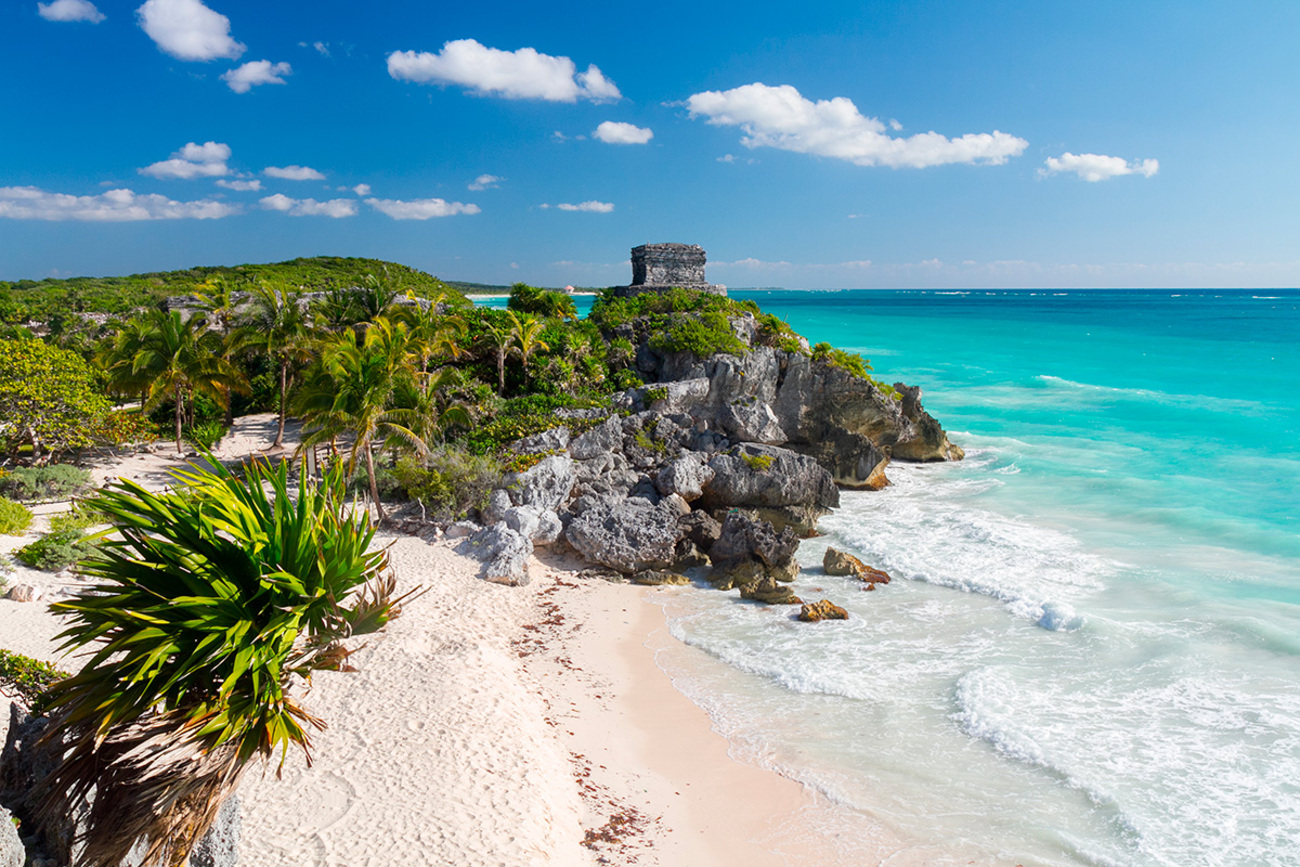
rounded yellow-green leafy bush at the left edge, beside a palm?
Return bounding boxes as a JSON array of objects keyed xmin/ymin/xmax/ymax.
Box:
[{"xmin": 0, "ymin": 339, "xmax": 109, "ymax": 460}]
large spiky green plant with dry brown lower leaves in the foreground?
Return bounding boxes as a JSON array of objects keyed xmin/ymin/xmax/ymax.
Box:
[{"xmin": 40, "ymin": 461, "xmax": 411, "ymax": 867}]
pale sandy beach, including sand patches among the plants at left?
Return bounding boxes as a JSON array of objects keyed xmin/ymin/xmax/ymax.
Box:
[{"xmin": 0, "ymin": 416, "xmax": 828, "ymax": 867}]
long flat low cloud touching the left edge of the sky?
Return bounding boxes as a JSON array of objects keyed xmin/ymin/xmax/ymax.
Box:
[{"xmin": 0, "ymin": 187, "xmax": 239, "ymax": 222}]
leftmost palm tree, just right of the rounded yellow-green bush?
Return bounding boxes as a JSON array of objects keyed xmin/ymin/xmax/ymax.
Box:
[{"xmin": 107, "ymin": 311, "xmax": 247, "ymax": 452}]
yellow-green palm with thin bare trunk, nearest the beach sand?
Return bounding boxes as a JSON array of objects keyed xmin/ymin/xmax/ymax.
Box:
[{"xmin": 299, "ymin": 317, "xmax": 428, "ymax": 521}]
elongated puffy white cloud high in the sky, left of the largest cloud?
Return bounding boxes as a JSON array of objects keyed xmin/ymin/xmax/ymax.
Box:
[{"xmin": 389, "ymin": 39, "xmax": 623, "ymax": 103}]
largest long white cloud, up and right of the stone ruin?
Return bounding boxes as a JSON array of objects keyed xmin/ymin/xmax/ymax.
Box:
[{"xmin": 686, "ymin": 82, "xmax": 1028, "ymax": 169}]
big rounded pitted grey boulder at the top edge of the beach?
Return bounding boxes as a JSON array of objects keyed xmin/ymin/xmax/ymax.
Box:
[{"xmin": 564, "ymin": 497, "xmax": 681, "ymax": 575}]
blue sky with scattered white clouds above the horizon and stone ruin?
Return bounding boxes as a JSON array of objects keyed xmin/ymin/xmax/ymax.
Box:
[{"xmin": 0, "ymin": 0, "xmax": 1300, "ymax": 287}]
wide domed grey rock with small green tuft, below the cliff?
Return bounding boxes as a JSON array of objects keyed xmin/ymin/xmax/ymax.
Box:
[{"xmin": 702, "ymin": 443, "xmax": 840, "ymax": 510}]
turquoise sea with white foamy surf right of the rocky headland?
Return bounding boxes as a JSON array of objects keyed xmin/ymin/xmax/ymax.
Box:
[{"xmin": 480, "ymin": 290, "xmax": 1300, "ymax": 867}]
